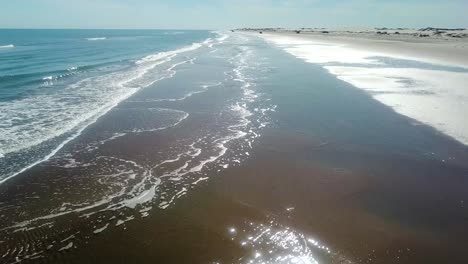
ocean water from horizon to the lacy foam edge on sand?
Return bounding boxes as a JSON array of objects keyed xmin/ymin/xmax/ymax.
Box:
[{"xmin": 0, "ymin": 30, "xmax": 304, "ymax": 262}]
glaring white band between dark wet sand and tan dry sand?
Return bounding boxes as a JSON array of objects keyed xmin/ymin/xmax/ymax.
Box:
[{"xmin": 264, "ymin": 35, "xmax": 468, "ymax": 145}]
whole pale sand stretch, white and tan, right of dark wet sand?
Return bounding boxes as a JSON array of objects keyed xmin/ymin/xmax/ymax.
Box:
[{"xmin": 249, "ymin": 32, "xmax": 468, "ymax": 148}]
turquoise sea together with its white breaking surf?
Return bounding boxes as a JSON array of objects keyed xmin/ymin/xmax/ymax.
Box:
[{"xmin": 0, "ymin": 30, "xmax": 214, "ymax": 182}]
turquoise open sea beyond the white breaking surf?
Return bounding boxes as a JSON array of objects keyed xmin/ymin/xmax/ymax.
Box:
[{"xmin": 0, "ymin": 29, "xmax": 213, "ymax": 101}]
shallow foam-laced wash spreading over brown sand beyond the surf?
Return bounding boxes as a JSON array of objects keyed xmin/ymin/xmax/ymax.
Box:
[{"xmin": 0, "ymin": 34, "xmax": 275, "ymax": 262}]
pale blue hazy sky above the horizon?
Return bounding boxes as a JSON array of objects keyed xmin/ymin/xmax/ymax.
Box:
[{"xmin": 0, "ymin": 0, "xmax": 468, "ymax": 29}]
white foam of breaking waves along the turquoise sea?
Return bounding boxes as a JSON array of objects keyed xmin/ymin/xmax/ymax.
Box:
[{"xmin": 0, "ymin": 40, "xmax": 205, "ymax": 184}]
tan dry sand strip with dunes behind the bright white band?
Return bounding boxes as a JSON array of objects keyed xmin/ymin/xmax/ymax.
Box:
[{"xmin": 243, "ymin": 29, "xmax": 468, "ymax": 67}]
